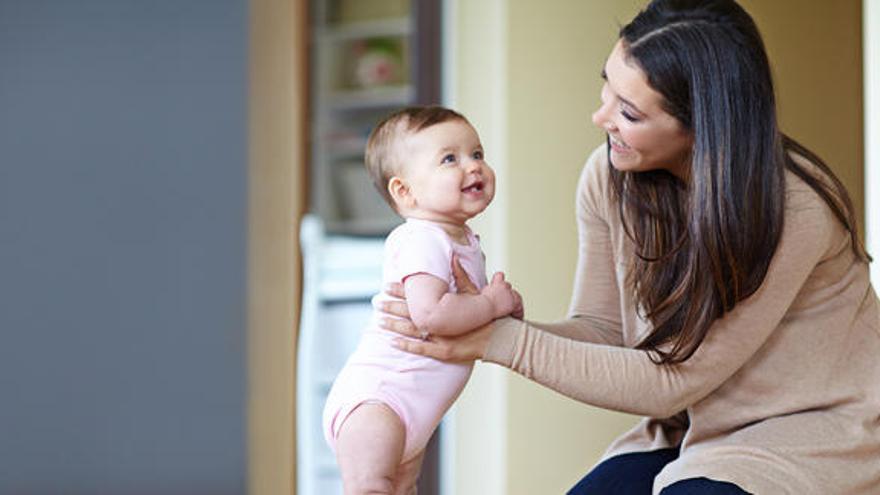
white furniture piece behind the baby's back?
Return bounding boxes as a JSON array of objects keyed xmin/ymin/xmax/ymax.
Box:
[{"xmin": 296, "ymin": 215, "xmax": 384, "ymax": 495}]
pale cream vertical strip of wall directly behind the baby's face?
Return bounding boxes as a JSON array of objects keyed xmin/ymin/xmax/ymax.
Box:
[{"xmin": 442, "ymin": 0, "xmax": 509, "ymax": 495}]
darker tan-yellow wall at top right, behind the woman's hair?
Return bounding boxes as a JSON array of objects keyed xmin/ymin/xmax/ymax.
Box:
[{"xmin": 740, "ymin": 0, "xmax": 864, "ymax": 232}]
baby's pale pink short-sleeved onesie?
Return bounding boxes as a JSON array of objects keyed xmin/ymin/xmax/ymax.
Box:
[{"xmin": 324, "ymin": 219, "xmax": 487, "ymax": 462}]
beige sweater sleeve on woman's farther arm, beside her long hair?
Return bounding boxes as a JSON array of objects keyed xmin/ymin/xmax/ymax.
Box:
[{"xmin": 530, "ymin": 146, "xmax": 623, "ymax": 346}]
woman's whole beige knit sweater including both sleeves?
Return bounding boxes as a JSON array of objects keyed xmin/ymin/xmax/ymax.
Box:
[{"xmin": 484, "ymin": 146, "xmax": 880, "ymax": 495}]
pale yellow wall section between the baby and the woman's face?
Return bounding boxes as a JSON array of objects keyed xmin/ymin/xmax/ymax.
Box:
[{"xmin": 507, "ymin": 0, "xmax": 642, "ymax": 495}]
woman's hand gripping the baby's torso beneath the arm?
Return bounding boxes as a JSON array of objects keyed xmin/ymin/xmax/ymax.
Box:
[{"xmin": 380, "ymin": 256, "xmax": 492, "ymax": 362}]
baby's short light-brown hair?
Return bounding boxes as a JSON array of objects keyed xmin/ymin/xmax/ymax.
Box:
[{"xmin": 364, "ymin": 105, "xmax": 468, "ymax": 211}]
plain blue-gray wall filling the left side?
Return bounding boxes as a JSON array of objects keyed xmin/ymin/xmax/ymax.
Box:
[{"xmin": 0, "ymin": 0, "xmax": 247, "ymax": 495}]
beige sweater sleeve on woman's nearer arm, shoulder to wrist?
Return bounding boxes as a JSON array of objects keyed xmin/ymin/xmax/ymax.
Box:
[{"xmin": 484, "ymin": 171, "xmax": 835, "ymax": 418}]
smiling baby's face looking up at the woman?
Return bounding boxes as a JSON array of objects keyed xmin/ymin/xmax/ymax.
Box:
[{"xmin": 398, "ymin": 120, "xmax": 495, "ymax": 224}]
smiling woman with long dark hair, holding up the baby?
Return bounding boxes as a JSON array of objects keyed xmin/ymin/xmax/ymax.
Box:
[{"xmin": 386, "ymin": 0, "xmax": 880, "ymax": 495}]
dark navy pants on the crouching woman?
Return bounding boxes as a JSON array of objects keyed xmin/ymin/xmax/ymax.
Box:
[{"xmin": 568, "ymin": 448, "xmax": 748, "ymax": 495}]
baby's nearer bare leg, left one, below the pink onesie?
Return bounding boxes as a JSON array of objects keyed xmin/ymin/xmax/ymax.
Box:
[{"xmin": 336, "ymin": 403, "xmax": 406, "ymax": 495}]
